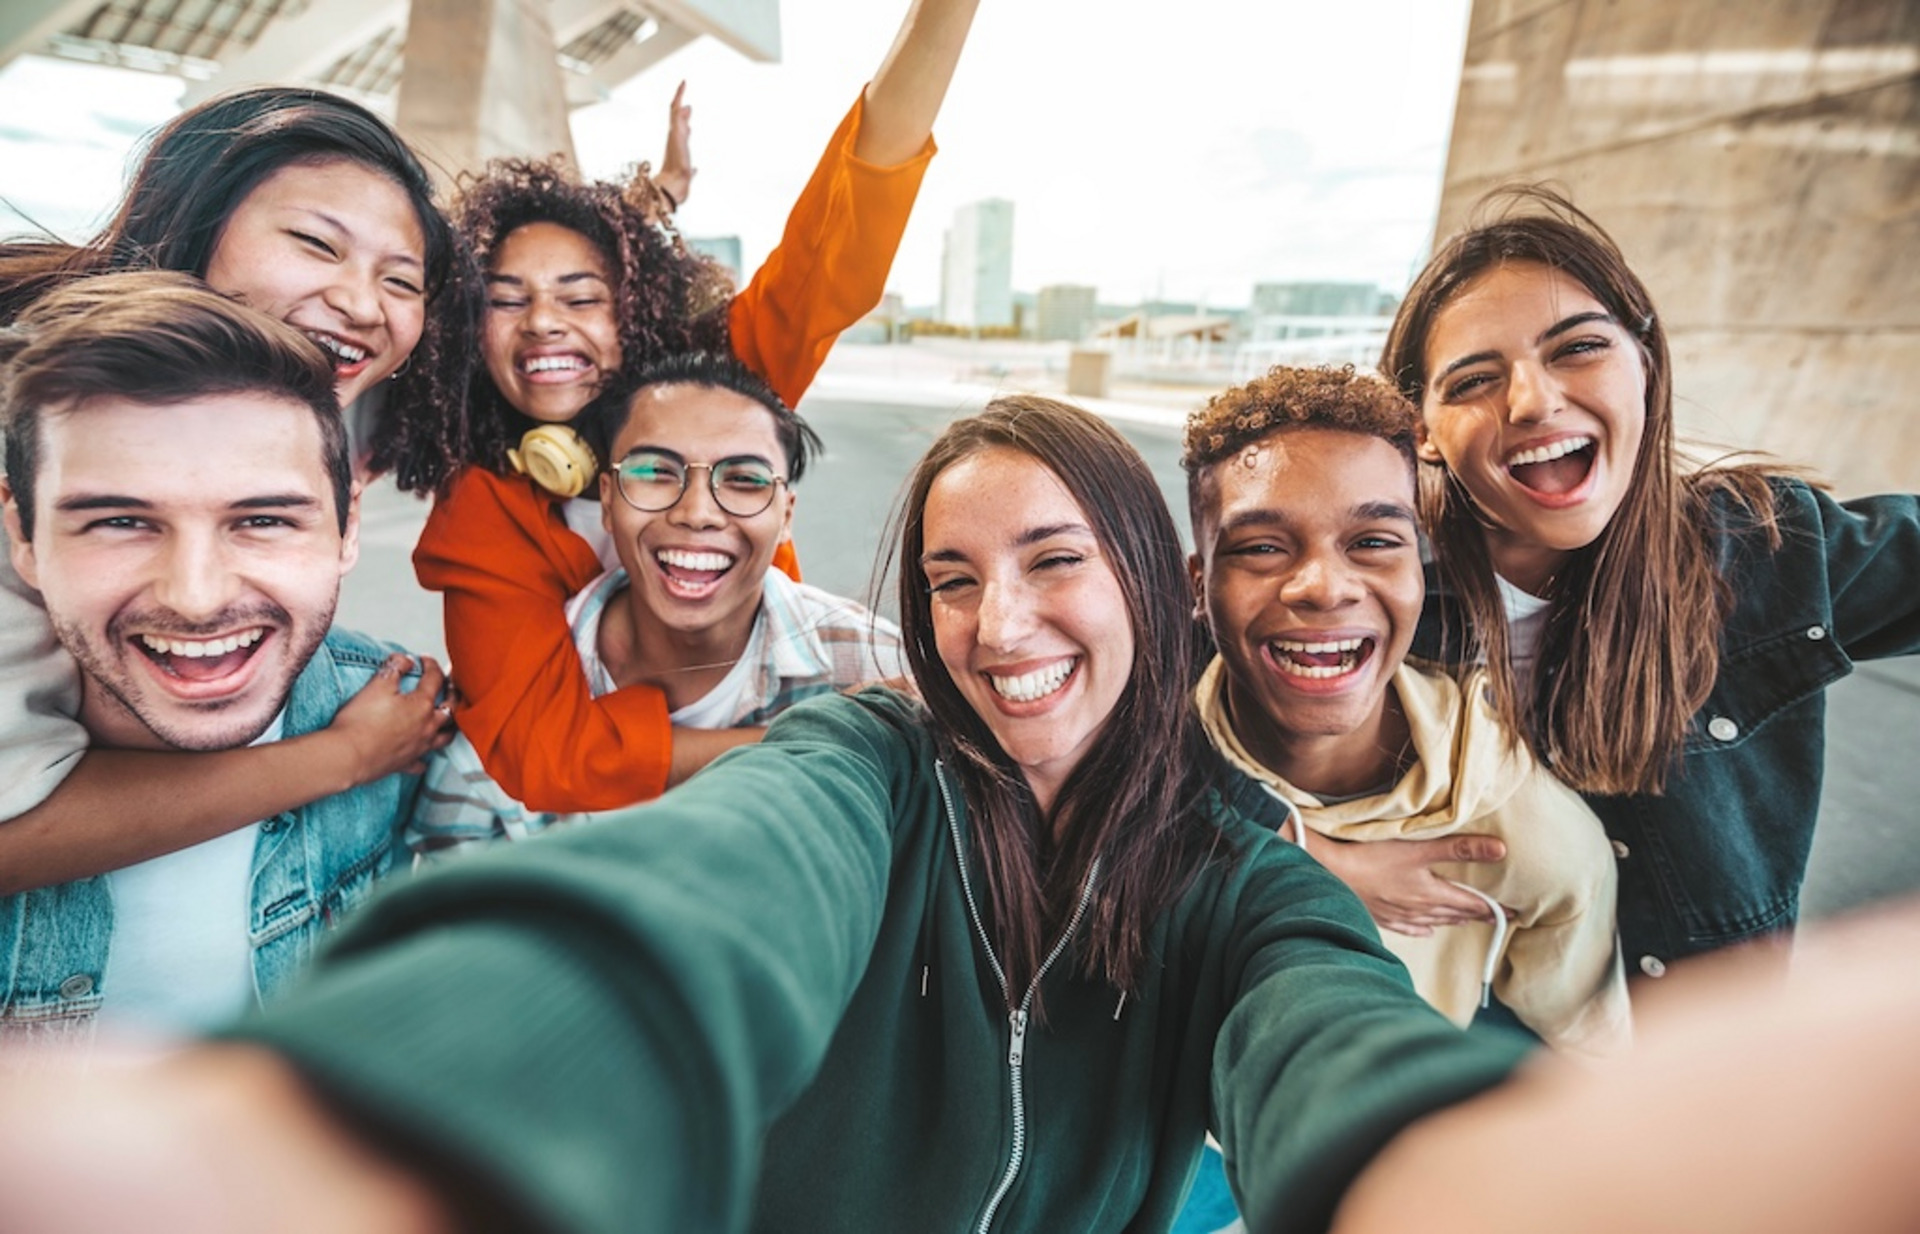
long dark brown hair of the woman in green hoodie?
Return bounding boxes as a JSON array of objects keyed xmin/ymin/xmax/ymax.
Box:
[{"xmin": 897, "ymin": 395, "xmax": 1219, "ymax": 1000}]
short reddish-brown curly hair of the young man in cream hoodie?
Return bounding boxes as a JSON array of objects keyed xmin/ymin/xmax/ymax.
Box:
[{"xmin": 1181, "ymin": 365, "xmax": 1419, "ymax": 526}]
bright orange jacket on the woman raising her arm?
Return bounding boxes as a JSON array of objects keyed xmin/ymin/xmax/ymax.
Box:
[{"xmin": 413, "ymin": 102, "xmax": 933, "ymax": 812}]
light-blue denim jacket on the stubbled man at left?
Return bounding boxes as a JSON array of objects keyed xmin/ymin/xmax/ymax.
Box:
[{"xmin": 0, "ymin": 629, "xmax": 419, "ymax": 1042}]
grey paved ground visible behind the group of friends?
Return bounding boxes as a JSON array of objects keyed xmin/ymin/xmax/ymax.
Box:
[{"xmin": 338, "ymin": 393, "xmax": 1920, "ymax": 919}]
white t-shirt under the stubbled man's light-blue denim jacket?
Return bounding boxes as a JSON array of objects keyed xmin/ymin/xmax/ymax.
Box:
[{"xmin": 100, "ymin": 714, "xmax": 284, "ymax": 1036}]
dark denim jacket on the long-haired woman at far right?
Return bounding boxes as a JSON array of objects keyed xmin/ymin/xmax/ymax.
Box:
[{"xmin": 1415, "ymin": 480, "xmax": 1920, "ymax": 977}]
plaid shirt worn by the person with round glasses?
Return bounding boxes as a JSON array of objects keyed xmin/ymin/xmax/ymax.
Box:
[{"xmin": 407, "ymin": 566, "xmax": 906, "ymax": 854}]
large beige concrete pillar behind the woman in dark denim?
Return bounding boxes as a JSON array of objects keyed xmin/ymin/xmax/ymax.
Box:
[{"xmin": 1440, "ymin": 0, "xmax": 1920, "ymax": 495}]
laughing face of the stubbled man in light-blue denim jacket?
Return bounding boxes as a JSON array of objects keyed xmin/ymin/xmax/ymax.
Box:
[{"xmin": 6, "ymin": 393, "xmax": 357, "ymax": 750}]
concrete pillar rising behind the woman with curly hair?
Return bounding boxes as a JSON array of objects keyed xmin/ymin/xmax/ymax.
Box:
[{"xmin": 396, "ymin": 0, "xmax": 574, "ymax": 177}]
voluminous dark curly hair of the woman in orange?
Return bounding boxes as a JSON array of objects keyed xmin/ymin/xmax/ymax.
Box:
[{"xmin": 376, "ymin": 155, "xmax": 733, "ymax": 493}]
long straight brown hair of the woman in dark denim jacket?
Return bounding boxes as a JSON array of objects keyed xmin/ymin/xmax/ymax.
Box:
[{"xmin": 1380, "ymin": 186, "xmax": 1780, "ymax": 793}]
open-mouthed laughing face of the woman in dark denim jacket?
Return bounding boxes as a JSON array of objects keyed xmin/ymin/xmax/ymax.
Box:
[{"xmin": 1421, "ymin": 261, "xmax": 1647, "ymax": 591}]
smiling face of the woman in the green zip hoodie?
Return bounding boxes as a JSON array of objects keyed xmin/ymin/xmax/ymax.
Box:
[{"xmin": 920, "ymin": 447, "xmax": 1133, "ymax": 814}]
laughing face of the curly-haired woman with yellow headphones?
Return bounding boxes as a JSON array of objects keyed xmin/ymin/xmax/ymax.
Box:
[{"xmin": 482, "ymin": 223, "xmax": 620, "ymax": 424}]
